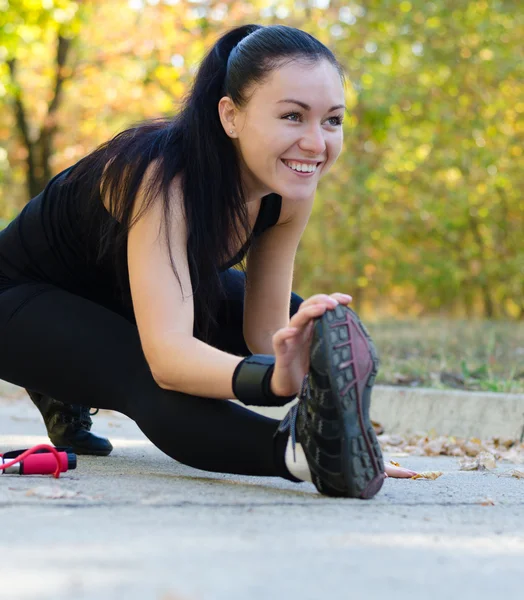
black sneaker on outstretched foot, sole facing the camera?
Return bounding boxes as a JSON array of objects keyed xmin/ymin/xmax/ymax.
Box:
[{"xmin": 279, "ymin": 304, "xmax": 385, "ymax": 499}]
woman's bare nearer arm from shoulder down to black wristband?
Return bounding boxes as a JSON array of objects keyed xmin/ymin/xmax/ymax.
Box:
[{"xmin": 127, "ymin": 165, "xmax": 242, "ymax": 398}]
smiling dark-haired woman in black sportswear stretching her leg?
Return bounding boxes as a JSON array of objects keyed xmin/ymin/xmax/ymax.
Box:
[{"xmin": 0, "ymin": 25, "xmax": 418, "ymax": 498}]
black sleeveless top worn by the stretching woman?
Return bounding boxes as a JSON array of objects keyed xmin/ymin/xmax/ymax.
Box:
[{"xmin": 0, "ymin": 159, "xmax": 282, "ymax": 321}]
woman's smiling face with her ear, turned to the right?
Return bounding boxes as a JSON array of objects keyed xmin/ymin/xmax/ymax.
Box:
[{"xmin": 218, "ymin": 59, "xmax": 344, "ymax": 202}]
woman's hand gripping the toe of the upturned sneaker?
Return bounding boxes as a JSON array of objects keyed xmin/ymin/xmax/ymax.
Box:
[{"xmin": 271, "ymin": 292, "xmax": 352, "ymax": 396}]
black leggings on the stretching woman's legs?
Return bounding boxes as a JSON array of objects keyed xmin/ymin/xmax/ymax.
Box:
[{"xmin": 0, "ymin": 270, "xmax": 302, "ymax": 479}]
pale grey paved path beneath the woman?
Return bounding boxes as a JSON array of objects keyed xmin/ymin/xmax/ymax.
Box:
[{"xmin": 0, "ymin": 397, "xmax": 524, "ymax": 600}]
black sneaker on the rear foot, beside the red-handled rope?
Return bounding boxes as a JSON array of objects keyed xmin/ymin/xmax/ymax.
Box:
[{"xmin": 26, "ymin": 390, "xmax": 113, "ymax": 456}]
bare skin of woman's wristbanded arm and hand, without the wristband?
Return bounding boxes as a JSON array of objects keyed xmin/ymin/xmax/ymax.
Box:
[{"xmin": 127, "ymin": 169, "xmax": 332, "ymax": 399}]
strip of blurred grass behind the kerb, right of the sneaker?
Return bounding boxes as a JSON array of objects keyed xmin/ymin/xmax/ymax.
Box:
[{"xmin": 366, "ymin": 318, "xmax": 524, "ymax": 393}]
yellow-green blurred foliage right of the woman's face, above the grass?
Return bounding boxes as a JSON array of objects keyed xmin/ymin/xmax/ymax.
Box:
[{"xmin": 298, "ymin": 0, "xmax": 524, "ymax": 317}]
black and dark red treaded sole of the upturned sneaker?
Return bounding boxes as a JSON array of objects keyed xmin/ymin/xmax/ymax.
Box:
[{"xmin": 311, "ymin": 305, "xmax": 385, "ymax": 499}]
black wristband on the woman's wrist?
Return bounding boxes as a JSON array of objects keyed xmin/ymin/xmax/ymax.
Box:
[{"xmin": 233, "ymin": 354, "xmax": 296, "ymax": 406}]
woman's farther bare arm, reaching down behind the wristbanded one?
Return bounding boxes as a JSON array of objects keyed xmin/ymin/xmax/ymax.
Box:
[{"xmin": 244, "ymin": 191, "xmax": 314, "ymax": 354}]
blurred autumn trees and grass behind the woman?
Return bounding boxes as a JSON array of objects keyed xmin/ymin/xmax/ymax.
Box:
[{"xmin": 0, "ymin": 0, "xmax": 524, "ymax": 391}]
